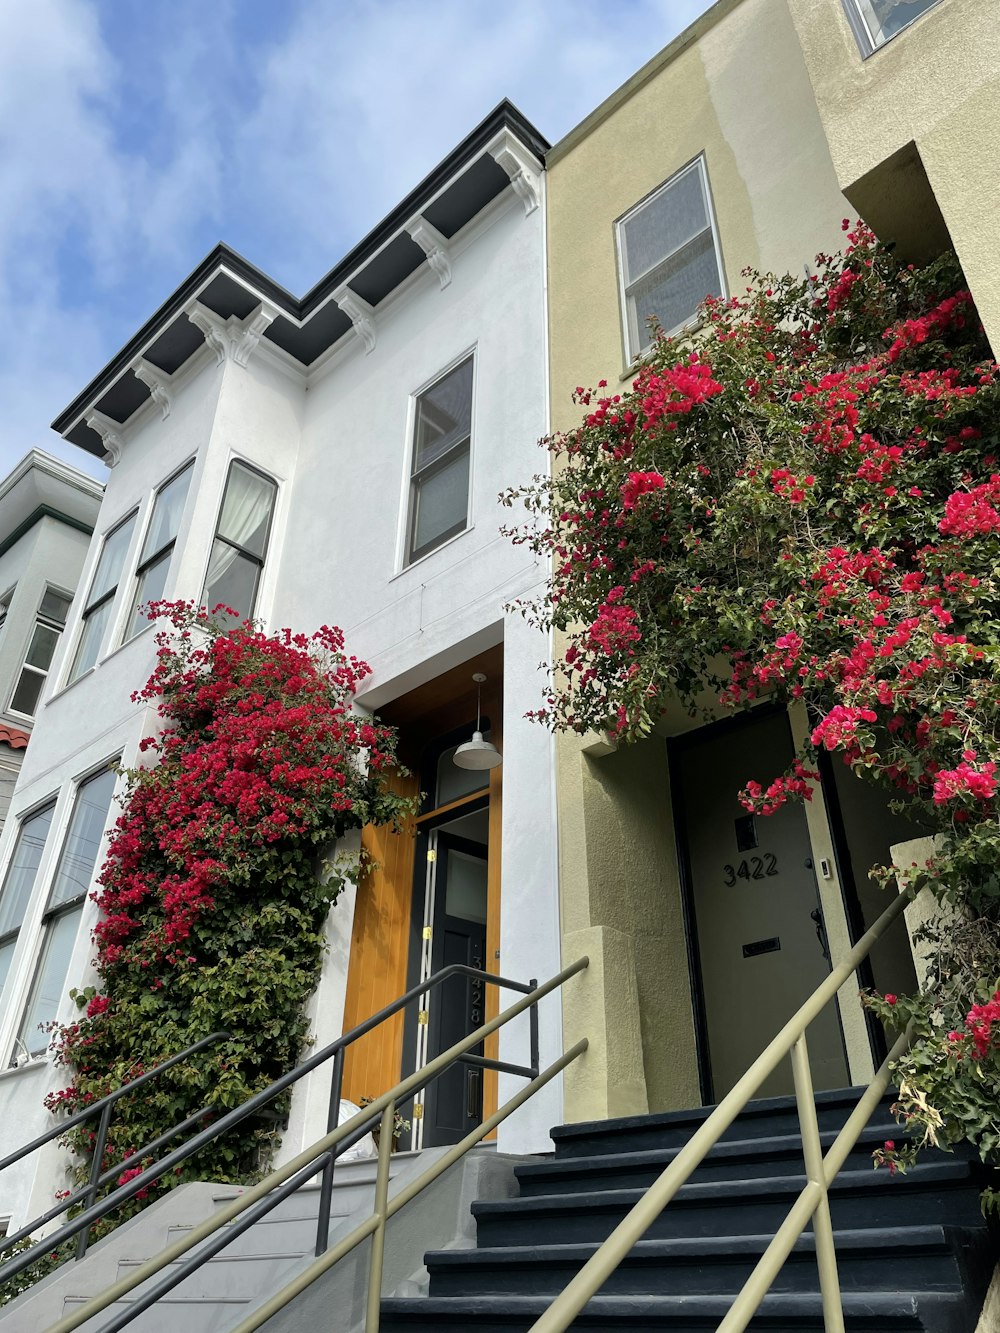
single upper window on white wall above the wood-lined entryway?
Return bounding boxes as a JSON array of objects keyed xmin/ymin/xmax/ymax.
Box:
[{"xmin": 405, "ymin": 356, "xmax": 473, "ymax": 564}]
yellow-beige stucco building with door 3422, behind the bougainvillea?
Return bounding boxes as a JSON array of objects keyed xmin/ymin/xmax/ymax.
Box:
[{"xmin": 547, "ymin": 0, "xmax": 1000, "ymax": 1120}]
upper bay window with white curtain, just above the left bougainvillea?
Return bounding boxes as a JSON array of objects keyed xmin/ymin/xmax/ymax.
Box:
[{"xmin": 201, "ymin": 460, "xmax": 277, "ymax": 620}]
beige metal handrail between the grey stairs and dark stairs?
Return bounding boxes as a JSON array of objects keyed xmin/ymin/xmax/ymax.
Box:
[{"xmin": 48, "ymin": 957, "xmax": 589, "ymax": 1333}]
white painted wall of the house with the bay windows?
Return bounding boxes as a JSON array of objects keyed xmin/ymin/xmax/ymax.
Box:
[{"xmin": 0, "ymin": 174, "xmax": 561, "ymax": 1224}]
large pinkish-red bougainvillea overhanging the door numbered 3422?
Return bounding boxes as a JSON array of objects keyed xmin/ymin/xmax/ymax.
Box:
[{"xmin": 503, "ymin": 224, "xmax": 1000, "ymax": 1194}]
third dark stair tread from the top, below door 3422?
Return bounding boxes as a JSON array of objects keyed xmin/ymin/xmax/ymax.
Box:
[{"xmin": 472, "ymin": 1158, "xmax": 975, "ymax": 1217}]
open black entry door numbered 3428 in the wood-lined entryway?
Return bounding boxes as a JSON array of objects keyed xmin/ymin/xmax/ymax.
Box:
[{"xmin": 424, "ymin": 832, "xmax": 487, "ymax": 1148}]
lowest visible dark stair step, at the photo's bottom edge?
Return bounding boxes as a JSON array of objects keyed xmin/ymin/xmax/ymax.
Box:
[{"xmin": 381, "ymin": 1292, "xmax": 961, "ymax": 1333}]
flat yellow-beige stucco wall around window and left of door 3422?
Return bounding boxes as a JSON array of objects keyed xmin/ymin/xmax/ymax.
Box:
[{"xmin": 548, "ymin": 0, "xmax": 848, "ymax": 1118}]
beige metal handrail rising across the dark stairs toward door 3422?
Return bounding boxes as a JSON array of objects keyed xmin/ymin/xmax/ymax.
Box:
[{"xmin": 529, "ymin": 890, "xmax": 911, "ymax": 1333}]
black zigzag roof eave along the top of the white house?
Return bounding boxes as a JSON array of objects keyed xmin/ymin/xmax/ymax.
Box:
[{"xmin": 52, "ymin": 100, "xmax": 549, "ymax": 442}]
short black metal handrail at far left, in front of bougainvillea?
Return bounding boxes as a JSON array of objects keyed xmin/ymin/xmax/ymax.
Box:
[{"xmin": 0, "ymin": 1032, "xmax": 229, "ymax": 1258}]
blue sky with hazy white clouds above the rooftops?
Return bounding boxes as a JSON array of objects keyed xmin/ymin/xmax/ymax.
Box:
[{"xmin": 0, "ymin": 0, "xmax": 708, "ymax": 476}]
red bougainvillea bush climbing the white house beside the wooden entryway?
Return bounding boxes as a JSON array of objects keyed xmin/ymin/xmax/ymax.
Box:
[{"xmin": 41, "ymin": 603, "xmax": 407, "ymax": 1234}]
